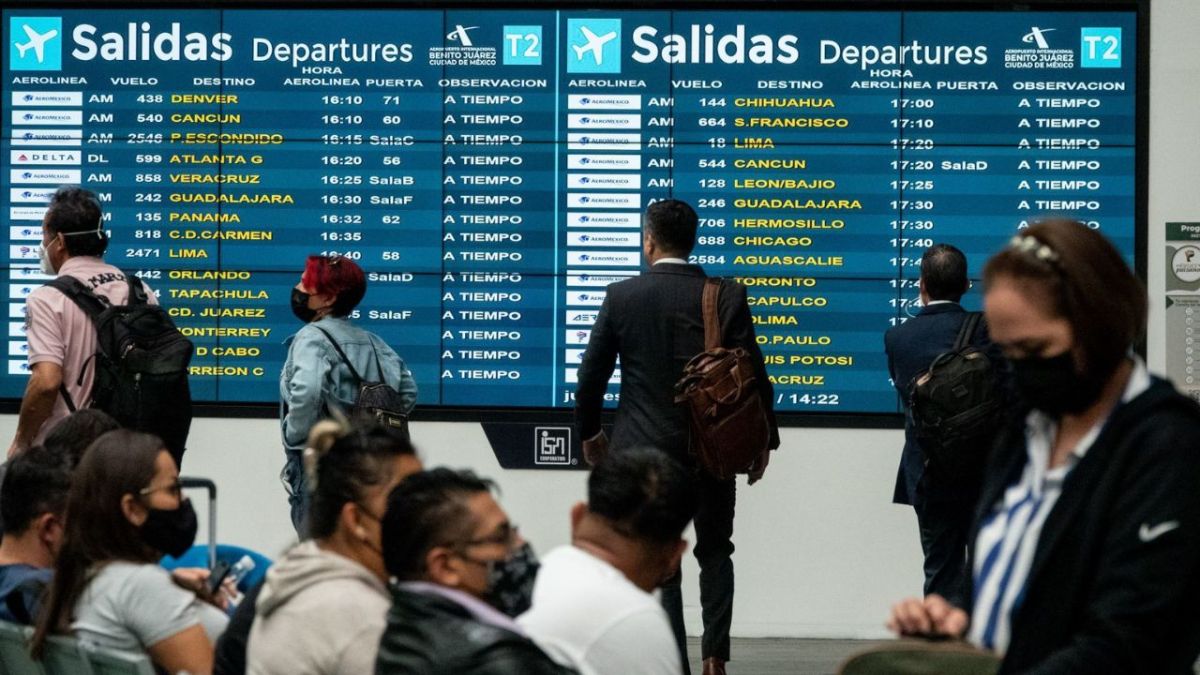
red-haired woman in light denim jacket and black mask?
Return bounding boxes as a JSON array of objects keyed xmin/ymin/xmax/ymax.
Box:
[{"xmin": 280, "ymin": 256, "xmax": 416, "ymax": 537}]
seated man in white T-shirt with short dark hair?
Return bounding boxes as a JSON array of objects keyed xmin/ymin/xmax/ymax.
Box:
[{"xmin": 517, "ymin": 448, "xmax": 696, "ymax": 675}]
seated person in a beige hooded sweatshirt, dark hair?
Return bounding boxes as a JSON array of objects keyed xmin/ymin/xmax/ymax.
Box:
[{"xmin": 243, "ymin": 422, "xmax": 421, "ymax": 675}]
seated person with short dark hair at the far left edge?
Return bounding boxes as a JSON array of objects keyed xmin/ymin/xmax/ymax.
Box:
[{"xmin": 0, "ymin": 446, "xmax": 71, "ymax": 625}]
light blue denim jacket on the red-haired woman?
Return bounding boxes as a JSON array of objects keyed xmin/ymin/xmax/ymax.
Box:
[{"xmin": 280, "ymin": 316, "xmax": 416, "ymax": 452}]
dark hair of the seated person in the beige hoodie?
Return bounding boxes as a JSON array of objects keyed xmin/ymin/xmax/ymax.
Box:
[{"xmin": 308, "ymin": 416, "xmax": 416, "ymax": 539}]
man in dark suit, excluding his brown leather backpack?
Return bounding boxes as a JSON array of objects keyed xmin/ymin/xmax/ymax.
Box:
[{"xmin": 575, "ymin": 199, "xmax": 779, "ymax": 675}]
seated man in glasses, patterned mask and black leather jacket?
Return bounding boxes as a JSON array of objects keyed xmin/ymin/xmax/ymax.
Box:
[{"xmin": 376, "ymin": 468, "xmax": 570, "ymax": 675}]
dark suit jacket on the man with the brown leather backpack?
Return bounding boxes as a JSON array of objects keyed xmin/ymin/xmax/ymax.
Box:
[{"xmin": 575, "ymin": 263, "xmax": 779, "ymax": 460}]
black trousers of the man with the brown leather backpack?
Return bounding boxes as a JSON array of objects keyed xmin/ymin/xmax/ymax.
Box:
[{"xmin": 662, "ymin": 472, "xmax": 737, "ymax": 675}]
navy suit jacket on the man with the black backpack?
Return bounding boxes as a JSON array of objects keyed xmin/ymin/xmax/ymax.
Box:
[{"xmin": 883, "ymin": 303, "xmax": 990, "ymax": 506}]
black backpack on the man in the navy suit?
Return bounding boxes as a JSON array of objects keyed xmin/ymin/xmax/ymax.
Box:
[{"xmin": 908, "ymin": 312, "xmax": 1004, "ymax": 478}]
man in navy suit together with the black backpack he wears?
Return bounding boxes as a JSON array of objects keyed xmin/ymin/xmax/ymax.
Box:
[{"xmin": 883, "ymin": 244, "xmax": 1004, "ymax": 602}]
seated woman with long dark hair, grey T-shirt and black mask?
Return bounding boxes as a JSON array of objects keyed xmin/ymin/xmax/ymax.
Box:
[{"xmin": 32, "ymin": 430, "xmax": 228, "ymax": 675}]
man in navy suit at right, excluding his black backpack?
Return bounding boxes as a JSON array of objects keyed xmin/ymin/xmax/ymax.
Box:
[{"xmin": 883, "ymin": 244, "xmax": 989, "ymax": 602}]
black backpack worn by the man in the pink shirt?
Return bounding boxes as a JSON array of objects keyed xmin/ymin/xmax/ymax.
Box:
[{"xmin": 47, "ymin": 275, "xmax": 193, "ymax": 465}]
